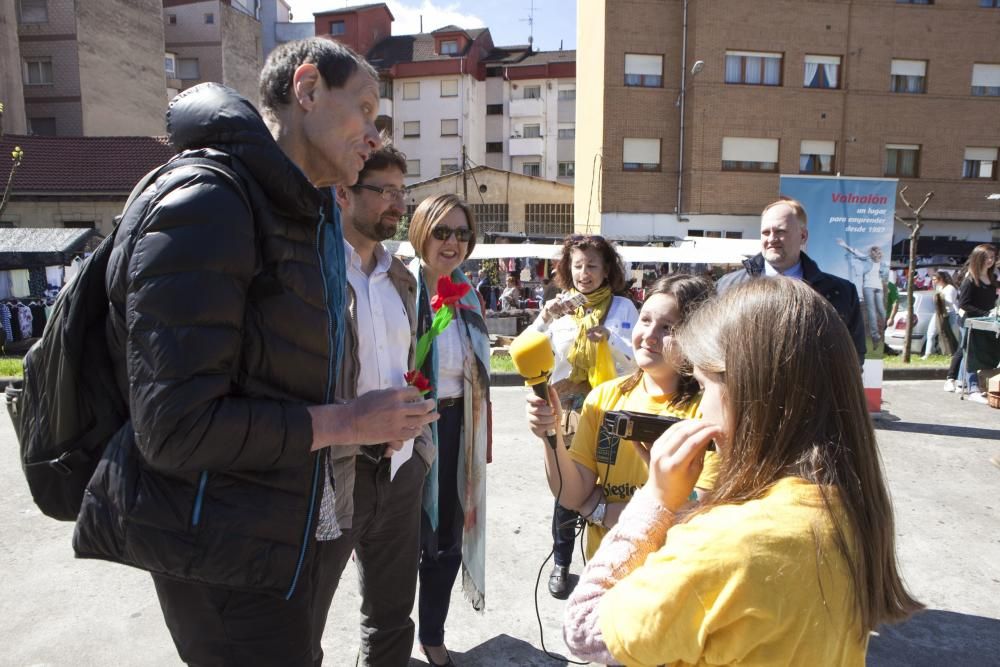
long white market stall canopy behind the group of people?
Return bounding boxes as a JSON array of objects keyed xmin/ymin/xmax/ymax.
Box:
[{"xmin": 385, "ymin": 236, "xmax": 760, "ymax": 264}]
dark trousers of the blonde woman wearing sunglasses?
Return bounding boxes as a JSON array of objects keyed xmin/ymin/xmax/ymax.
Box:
[{"xmin": 418, "ymin": 403, "xmax": 464, "ymax": 646}]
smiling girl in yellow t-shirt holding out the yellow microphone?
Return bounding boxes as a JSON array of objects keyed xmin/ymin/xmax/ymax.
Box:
[{"xmin": 527, "ymin": 274, "xmax": 714, "ymax": 576}]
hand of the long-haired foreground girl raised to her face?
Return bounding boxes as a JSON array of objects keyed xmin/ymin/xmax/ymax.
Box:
[{"xmin": 637, "ymin": 419, "xmax": 722, "ymax": 512}]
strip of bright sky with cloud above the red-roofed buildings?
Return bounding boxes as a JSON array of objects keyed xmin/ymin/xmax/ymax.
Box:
[{"xmin": 288, "ymin": 0, "xmax": 576, "ymax": 51}]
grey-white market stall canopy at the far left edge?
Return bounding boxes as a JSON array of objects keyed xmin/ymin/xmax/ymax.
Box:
[{"xmin": 0, "ymin": 227, "xmax": 100, "ymax": 271}]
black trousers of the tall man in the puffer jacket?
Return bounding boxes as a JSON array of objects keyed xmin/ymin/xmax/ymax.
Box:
[{"xmin": 152, "ymin": 540, "xmax": 340, "ymax": 667}]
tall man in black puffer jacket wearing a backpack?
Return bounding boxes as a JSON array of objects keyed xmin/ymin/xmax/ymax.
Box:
[{"xmin": 73, "ymin": 39, "xmax": 436, "ymax": 666}]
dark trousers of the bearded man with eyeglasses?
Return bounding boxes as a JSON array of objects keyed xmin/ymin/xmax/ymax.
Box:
[{"xmin": 324, "ymin": 452, "xmax": 427, "ymax": 667}]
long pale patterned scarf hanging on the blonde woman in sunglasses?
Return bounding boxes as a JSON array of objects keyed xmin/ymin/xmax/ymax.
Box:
[{"xmin": 410, "ymin": 260, "xmax": 490, "ymax": 611}]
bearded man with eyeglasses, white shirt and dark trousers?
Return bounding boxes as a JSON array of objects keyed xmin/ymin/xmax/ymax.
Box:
[{"xmin": 320, "ymin": 146, "xmax": 434, "ymax": 665}]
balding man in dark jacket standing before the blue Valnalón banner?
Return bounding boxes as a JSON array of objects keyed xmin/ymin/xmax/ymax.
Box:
[{"xmin": 716, "ymin": 199, "xmax": 866, "ymax": 365}]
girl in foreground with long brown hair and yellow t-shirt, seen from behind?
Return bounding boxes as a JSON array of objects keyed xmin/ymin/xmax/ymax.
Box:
[{"xmin": 564, "ymin": 278, "xmax": 921, "ymax": 667}]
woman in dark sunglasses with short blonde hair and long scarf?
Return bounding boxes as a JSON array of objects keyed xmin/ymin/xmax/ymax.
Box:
[{"xmin": 409, "ymin": 194, "xmax": 490, "ymax": 665}]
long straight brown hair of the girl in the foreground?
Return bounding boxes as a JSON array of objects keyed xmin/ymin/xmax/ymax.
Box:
[{"xmin": 678, "ymin": 278, "xmax": 922, "ymax": 634}]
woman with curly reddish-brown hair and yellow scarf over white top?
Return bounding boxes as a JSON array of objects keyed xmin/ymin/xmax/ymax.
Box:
[{"xmin": 531, "ymin": 235, "xmax": 639, "ymax": 600}]
